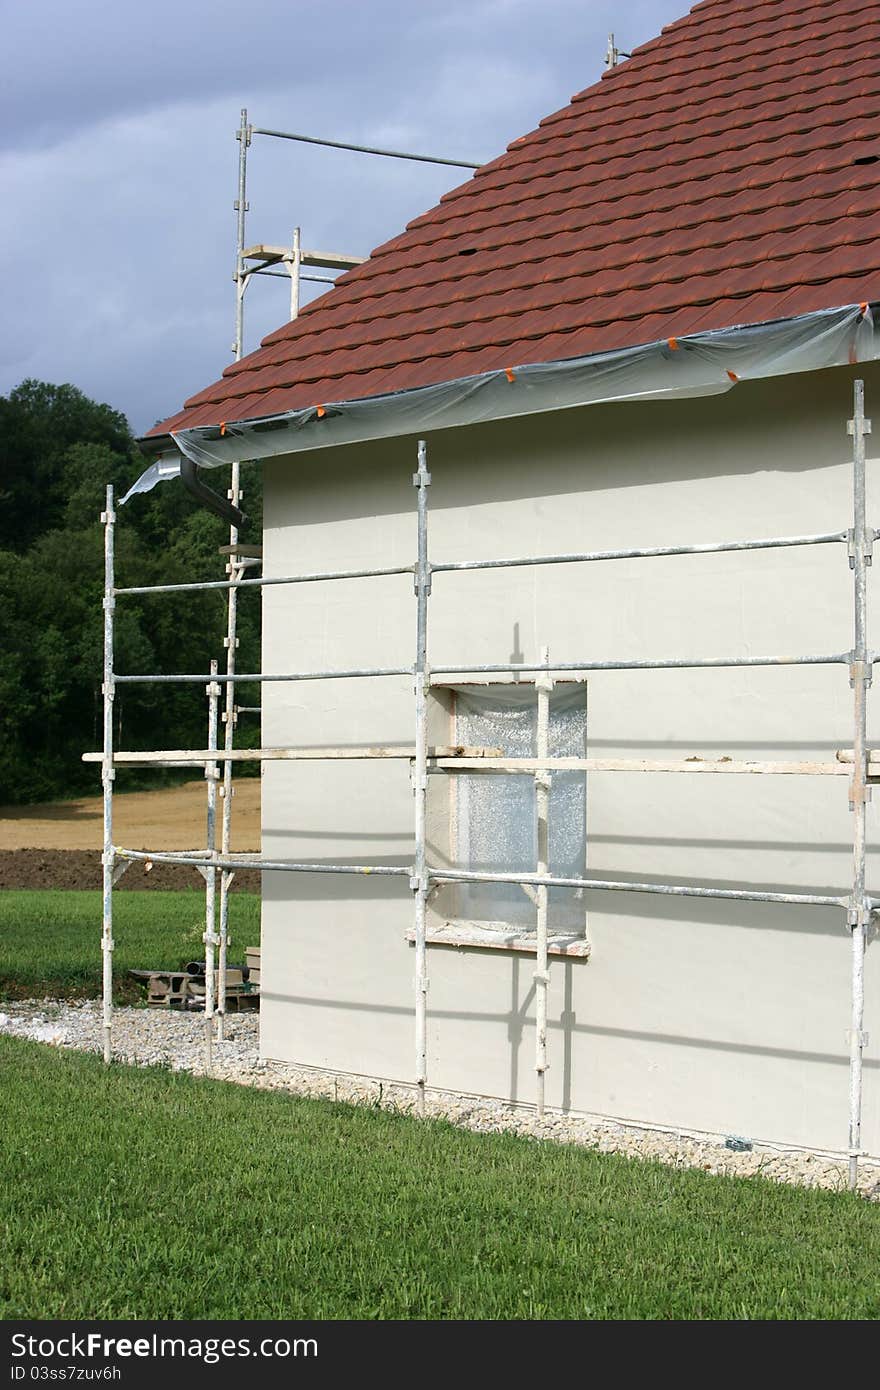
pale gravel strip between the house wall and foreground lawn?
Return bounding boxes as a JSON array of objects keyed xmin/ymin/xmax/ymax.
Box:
[{"xmin": 0, "ymin": 999, "xmax": 880, "ymax": 1201}]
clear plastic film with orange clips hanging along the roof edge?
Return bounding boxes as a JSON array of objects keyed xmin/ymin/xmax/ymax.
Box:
[{"xmin": 122, "ymin": 304, "xmax": 880, "ymax": 503}]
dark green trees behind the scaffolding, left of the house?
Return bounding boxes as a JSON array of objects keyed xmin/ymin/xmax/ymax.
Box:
[{"xmin": 0, "ymin": 381, "xmax": 261, "ymax": 805}]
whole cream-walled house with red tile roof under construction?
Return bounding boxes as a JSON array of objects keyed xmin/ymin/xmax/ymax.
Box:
[{"xmin": 137, "ymin": 0, "xmax": 880, "ymax": 1154}]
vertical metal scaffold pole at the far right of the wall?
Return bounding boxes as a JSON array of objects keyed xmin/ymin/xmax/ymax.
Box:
[{"xmin": 847, "ymin": 381, "xmax": 873, "ymax": 1190}]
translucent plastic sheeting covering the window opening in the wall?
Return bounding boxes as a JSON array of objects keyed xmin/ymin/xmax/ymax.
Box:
[{"xmin": 450, "ymin": 684, "xmax": 587, "ymax": 931}]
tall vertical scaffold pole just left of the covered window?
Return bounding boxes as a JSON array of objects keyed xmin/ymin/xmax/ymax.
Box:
[{"xmin": 410, "ymin": 439, "xmax": 431, "ymax": 1115}]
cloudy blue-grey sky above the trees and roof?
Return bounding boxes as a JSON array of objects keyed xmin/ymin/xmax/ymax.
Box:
[{"xmin": 0, "ymin": 0, "xmax": 690, "ymax": 432}]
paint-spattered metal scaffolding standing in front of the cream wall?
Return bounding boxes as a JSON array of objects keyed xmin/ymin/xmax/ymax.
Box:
[{"xmin": 85, "ymin": 381, "xmax": 880, "ymax": 1187}]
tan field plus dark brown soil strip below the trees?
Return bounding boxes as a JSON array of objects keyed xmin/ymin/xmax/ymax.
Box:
[{"xmin": 0, "ymin": 777, "xmax": 260, "ymax": 892}]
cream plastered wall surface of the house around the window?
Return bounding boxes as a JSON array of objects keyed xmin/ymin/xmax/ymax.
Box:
[{"xmin": 261, "ymin": 367, "xmax": 880, "ymax": 1151}]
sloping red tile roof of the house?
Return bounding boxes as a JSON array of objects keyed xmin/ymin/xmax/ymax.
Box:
[{"xmin": 150, "ymin": 0, "xmax": 880, "ymax": 435}]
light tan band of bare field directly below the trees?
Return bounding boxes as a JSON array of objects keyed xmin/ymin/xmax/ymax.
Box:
[{"xmin": 0, "ymin": 777, "xmax": 260, "ymax": 851}]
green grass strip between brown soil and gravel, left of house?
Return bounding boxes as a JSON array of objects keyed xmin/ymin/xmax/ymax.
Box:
[{"xmin": 0, "ymin": 890, "xmax": 260, "ymax": 1002}]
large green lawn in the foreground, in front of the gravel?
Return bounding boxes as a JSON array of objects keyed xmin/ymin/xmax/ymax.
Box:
[{"xmin": 0, "ymin": 1037, "xmax": 880, "ymax": 1319}]
